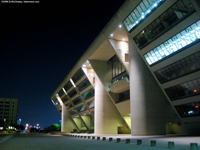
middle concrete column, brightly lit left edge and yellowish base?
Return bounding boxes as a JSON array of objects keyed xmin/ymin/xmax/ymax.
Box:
[{"xmin": 94, "ymin": 75, "xmax": 120, "ymax": 134}]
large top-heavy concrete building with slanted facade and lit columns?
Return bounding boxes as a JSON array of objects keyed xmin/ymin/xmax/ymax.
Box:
[{"xmin": 51, "ymin": 0, "xmax": 200, "ymax": 135}]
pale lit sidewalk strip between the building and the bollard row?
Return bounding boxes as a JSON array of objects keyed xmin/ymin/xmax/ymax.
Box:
[{"xmin": 63, "ymin": 134, "xmax": 200, "ymax": 150}]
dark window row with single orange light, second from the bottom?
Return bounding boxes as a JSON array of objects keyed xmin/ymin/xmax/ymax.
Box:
[{"xmin": 165, "ymin": 78, "xmax": 200, "ymax": 101}]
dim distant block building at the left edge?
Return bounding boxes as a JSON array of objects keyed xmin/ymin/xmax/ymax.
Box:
[{"xmin": 0, "ymin": 98, "xmax": 18, "ymax": 125}]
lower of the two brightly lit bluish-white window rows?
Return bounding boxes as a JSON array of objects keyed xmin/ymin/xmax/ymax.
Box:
[{"xmin": 144, "ymin": 21, "xmax": 200, "ymax": 65}]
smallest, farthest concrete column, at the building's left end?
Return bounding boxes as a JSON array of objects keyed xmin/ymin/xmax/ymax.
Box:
[{"xmin": 61, "ymin": 105, "xmax": 77, "ymax": 132}]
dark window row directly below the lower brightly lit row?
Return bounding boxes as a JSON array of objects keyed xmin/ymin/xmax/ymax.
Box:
[{"xmin": 154, "ymin": 51, "xmax": 200, "ymax": 83}]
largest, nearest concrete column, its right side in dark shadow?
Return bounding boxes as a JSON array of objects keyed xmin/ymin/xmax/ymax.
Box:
[{"xmin": 129, "ymin": 38, "xmax": 174, "ymax": 135}]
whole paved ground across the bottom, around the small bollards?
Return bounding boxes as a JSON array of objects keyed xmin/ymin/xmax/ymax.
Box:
[{"xmin": 0, "ymin": 134, "xmax": 200, "ymax": 150}]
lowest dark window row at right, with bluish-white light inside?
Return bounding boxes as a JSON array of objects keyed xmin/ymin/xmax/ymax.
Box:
[{"xmin": 175, "ymin": 102, "xmax": 200, "ymax": 118}]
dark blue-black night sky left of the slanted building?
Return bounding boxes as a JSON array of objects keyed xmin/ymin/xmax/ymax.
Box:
[{"xmin": 0, "ymin": 0, "xmax": 125, "ymax": 127}]
